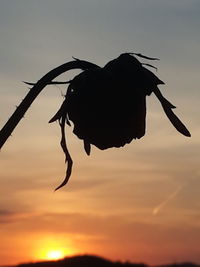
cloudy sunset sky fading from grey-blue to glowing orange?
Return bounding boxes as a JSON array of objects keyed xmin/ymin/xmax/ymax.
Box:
[{"xmin": 0, "ymin": 0, "xmax": 200, "ymax": 265}]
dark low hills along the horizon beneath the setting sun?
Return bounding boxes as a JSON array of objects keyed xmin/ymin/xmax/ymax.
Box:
[{"xmin": 6, "ymin": 255, "xmax": 200, "ymax": 267}]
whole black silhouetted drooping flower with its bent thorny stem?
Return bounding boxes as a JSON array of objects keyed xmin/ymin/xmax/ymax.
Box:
[{"xmin": 0, "ymin": 53, "xmax": 190, "ymax": 190}]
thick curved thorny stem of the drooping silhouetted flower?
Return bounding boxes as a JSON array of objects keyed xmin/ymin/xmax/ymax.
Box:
[{"xmin": 0, "ymin": 60, "xmax": 98, "ymax": 149}]
